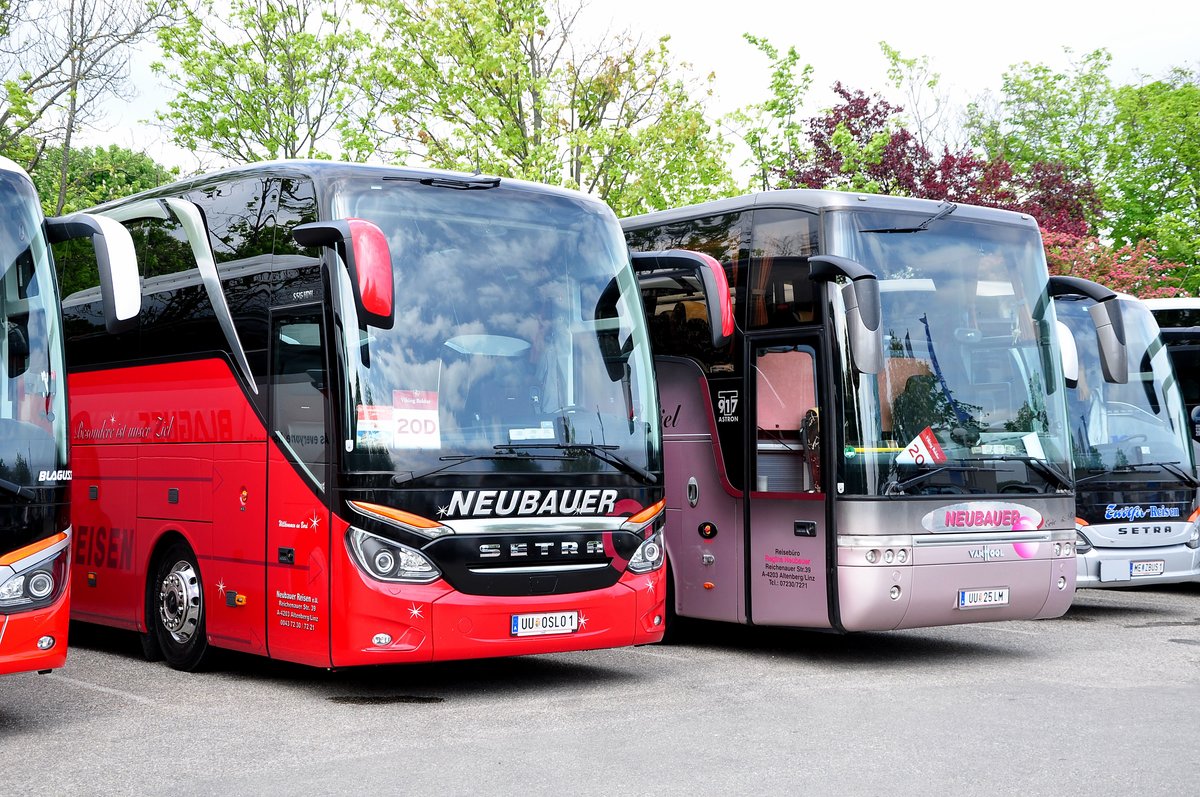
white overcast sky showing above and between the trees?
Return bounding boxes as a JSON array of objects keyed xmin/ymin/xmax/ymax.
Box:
[{"xmin": 85, "ymin": 0, "xmax": 1200, "ymax": 176}]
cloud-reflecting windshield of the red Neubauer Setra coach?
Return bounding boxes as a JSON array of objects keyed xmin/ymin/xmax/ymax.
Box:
[{"xmin": 334, "ymin": 178, "xmax": 661, "ymax": 483}]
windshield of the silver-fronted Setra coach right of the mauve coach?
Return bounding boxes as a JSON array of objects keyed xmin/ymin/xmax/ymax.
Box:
[{"xmin": 1055, "ymin": 296, "xmax": 1193, "ymax": 477}]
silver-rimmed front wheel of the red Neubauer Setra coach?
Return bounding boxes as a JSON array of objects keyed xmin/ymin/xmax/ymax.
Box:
[{"xmin": 148, "ymin": 543, "xmax": 209, "ymax": 672}]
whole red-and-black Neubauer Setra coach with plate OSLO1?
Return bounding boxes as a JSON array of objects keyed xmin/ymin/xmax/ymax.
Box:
[{"xmin": 64, "ymin": 161, "xmax": 665, "ymax": 670}]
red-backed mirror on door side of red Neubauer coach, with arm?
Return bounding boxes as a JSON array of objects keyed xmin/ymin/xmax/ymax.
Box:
[{"xmin": 292, "ymin": 218, "xmax": 396, "ymax": 329}]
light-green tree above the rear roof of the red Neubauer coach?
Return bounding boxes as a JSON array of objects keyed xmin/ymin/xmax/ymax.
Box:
[{"xmin": 154, "ymin": 0, "xmax": 370, "ymax": 163}]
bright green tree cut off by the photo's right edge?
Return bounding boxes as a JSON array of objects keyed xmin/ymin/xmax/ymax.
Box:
[{"xmin": 1108, "ymin": 68, "xmax": 1200, "ymax": 271}]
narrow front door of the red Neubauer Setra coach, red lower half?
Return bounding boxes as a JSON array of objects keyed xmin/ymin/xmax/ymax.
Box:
[{"xmin": 266, "ymin": 305, "xmax": 332, "ymax": 666}]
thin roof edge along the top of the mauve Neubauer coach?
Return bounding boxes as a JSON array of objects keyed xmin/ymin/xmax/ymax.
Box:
[{"xmin": 622, "ymin": 188, "xmax": 1037, "ymax": 228}]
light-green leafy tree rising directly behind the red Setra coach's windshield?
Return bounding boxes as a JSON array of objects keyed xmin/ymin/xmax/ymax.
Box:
[{"xmin": 348, "ymin": 0, "xmax": 733, "ymax": 215}]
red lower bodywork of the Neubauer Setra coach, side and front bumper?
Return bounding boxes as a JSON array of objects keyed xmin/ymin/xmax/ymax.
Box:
[{"xmin": 70, "ymin": 359, "xmax": 666, "ymax": 667}]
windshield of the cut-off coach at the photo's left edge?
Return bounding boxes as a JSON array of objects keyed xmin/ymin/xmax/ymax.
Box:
[{"xmin": 0, "ymin": 170, "xmax": 67, "ymax": 503}]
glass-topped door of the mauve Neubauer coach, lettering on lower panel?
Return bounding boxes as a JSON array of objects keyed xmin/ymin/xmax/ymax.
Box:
[{"xmin": 745, "ymin": 332, "xmax": 829, "ymax": 628}]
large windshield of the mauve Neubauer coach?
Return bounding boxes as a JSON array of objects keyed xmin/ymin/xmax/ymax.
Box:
[{"xmin": 829, "ymin": 209, "xmax": 1070, "ymax": 496}]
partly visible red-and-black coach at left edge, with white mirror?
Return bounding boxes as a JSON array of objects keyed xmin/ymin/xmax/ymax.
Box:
[{"xmin": 0, "ymin": 153, "xmax": 138, "ymax": 675}]
